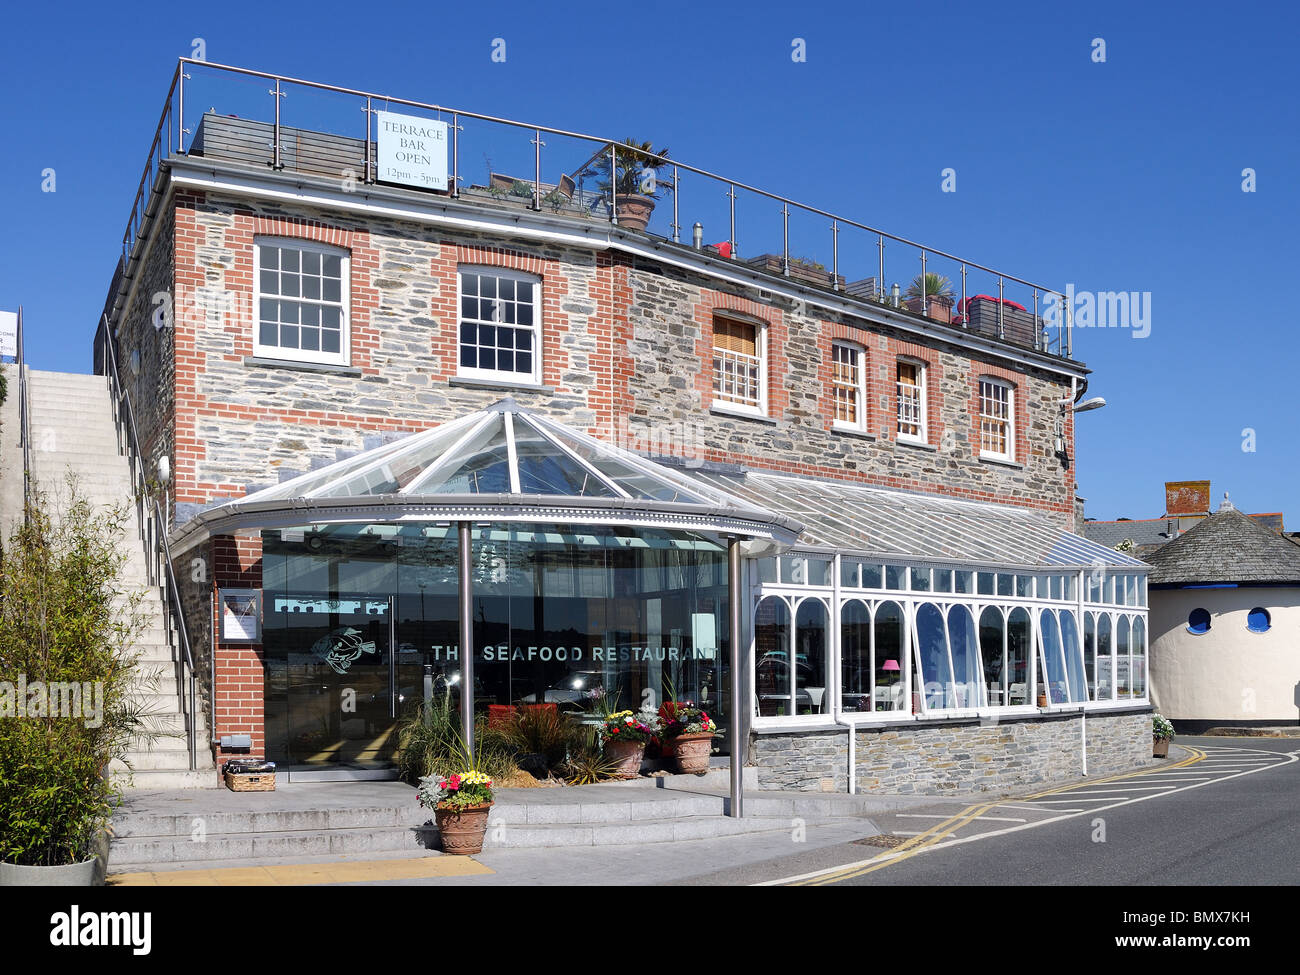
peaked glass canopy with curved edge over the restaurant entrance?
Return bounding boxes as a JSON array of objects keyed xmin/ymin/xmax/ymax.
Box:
[{"xmin": 177, "ymin": 399, "xmax": 801, "ymax": 554}]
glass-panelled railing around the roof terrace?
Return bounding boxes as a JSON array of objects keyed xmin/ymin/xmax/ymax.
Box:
[{"xmin": 105, "ymin": 57, "xmax": 1073, "ymax": 358}]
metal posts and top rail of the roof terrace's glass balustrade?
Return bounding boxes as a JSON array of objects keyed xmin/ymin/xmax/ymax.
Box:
[{"xmin": 108, "ymin": 57, "xmax": 1073, "ymax": 356}]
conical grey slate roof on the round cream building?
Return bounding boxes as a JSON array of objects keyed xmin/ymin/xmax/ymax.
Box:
[{"xmin": 1145, "ymin": 501, "xmax": 1300, "ymax": 585}]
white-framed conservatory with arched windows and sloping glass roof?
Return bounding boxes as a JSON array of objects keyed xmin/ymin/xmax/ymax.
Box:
[{"xmin": 696, "ymin": 472, "xmax": 1147, "ymax": 727}]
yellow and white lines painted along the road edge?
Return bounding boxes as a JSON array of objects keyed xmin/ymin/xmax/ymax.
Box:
[{"xmin": 757, "ymin": 746, "xmax": 1300, "ymax": 887}]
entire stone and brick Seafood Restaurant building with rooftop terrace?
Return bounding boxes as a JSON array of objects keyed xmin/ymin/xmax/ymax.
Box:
[{"xmin": 96, "ymin": 61, "xmax": 1151, "ymax": 792}]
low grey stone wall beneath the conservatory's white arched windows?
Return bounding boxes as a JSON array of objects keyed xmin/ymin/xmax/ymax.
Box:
[{"xmin": 750, "ymin": 709, "xmax": 1152, "ymax": 796}]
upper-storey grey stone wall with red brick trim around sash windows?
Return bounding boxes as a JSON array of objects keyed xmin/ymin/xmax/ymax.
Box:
[{"xmin": 160, "ymin": 194, "xmax": 1074, "ymax": 527}]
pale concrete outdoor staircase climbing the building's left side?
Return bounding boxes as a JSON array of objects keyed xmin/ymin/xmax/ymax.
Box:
[{"xmin": 26, "ymin": 369, "xmax": 217, "ymax": 789}]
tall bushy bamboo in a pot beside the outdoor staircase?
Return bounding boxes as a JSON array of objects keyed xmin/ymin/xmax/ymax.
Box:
[{"xmin": 0, "ymin": 478, "xmax": 150, "ymax": 887}]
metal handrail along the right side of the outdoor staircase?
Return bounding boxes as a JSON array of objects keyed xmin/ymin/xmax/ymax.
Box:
[{"xmin": 100, "ymin": 315, "xmax": 198, "ymax": 772}]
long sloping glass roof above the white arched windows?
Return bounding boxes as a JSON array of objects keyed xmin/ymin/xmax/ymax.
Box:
[{"xmin": 690, "ymin": 472, "xmax": 1145, "ymax": 568}]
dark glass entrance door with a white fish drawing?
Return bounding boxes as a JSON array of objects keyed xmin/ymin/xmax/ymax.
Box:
[{"xmin": 263, "ymin": 593, "xmax": 398, "ymax": 779}]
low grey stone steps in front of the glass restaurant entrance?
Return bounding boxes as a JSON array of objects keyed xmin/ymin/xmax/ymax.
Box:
[{"xmin": 112, "ymin": 770, "xmax": 885, "ymax": 872}]
